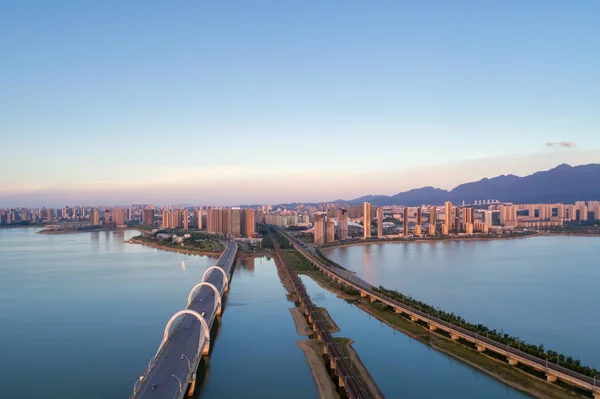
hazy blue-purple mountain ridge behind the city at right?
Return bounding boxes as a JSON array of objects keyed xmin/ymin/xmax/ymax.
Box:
[{"xmin": 324, "ymin": 164, "xmax": 600, "ymax": 206}]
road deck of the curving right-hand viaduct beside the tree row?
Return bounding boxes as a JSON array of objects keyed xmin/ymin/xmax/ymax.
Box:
[{"xmin": 277, "ymin": 228, "xmax": 600, "ymax": 398}]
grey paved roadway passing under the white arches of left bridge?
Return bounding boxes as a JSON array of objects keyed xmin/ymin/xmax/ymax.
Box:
[{"xmin": 131, "ymin": 242, "xmax": 237, "ymax": 399}]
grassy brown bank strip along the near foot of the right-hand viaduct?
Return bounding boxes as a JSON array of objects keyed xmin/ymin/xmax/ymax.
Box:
[{"xmin": 301, "ymin": 271, "xmax": 581, "ymax": 399}]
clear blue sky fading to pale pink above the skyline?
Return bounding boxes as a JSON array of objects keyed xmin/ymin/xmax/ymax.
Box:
[{"xmin": 0, "ymin": 0, "xmax": 600, "ymax": 206}]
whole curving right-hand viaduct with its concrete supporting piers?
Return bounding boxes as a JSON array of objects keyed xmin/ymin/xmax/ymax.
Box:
[{"xmin": 275, "ymin": 227, "xmax": 600, "ymax": 399}]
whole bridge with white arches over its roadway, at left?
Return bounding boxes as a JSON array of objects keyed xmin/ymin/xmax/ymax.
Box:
[{"xmin": 130, "ymin": 241, "xmax": 237, "ymax": 399}]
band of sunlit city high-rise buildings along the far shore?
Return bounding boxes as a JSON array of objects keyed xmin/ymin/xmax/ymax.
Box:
[{"xmin": 0, "ymin": 200, "xmax": 600, "ymax": 244}]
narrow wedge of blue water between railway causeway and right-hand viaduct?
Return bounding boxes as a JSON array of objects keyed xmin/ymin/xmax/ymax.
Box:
[{"xmin": 302, "ymin": 277, "xmax": 529, "ymax": 399}]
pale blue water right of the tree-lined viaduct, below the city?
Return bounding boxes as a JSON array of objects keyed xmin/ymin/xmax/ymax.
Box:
[{"xmin": 326, "ymin": 237, "xmax": 600, "ymax": 368}]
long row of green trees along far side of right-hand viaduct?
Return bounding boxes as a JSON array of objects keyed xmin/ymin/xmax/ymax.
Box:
[{"xmin": 373, "ymin": 286, "xmax": 600, "ymax": 377}]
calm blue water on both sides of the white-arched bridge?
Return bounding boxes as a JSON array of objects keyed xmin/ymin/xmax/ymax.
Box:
[{"xmin": 0, "ymin": 229, "xmax": 316, "ymax": 399}]
